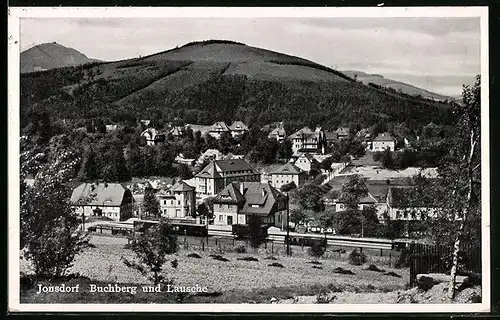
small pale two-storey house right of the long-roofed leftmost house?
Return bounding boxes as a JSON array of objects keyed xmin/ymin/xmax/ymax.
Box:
[{"xmin": 156, "ymin": 181, "xmax": 196, "ymax": 219}]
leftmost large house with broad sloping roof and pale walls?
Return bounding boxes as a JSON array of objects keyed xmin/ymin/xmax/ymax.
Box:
[{"xmin": 70, "ymin": 183, "xmax": 134, "ymax": 221}]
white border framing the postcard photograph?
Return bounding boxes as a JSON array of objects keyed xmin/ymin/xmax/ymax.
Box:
[{"xmin": 8, "ymin": 7, "xmax": 491, "ymax": 313}]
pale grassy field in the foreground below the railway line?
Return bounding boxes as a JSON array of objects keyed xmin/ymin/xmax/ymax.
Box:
[{"xmin": 21, "ymin": 236, "xmax": 409, "ymax": 303}]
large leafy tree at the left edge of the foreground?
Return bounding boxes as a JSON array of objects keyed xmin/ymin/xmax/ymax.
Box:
[{"xmin": 20, "ymin": 139, "xmax": 89, "ymax": 277}]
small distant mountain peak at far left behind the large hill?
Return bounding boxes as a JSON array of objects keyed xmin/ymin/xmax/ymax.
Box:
[{"xmin": 21, "ymin": 42, "xmax": 101, "ymax": 73}]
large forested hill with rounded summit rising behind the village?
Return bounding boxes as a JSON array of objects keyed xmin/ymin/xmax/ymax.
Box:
[{"xmin": 21, "ymin": 40, "xmax": 458, "ymax": 132}]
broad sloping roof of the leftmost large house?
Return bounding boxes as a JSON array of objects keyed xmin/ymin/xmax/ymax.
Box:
[{"xmin": 70, "ymin": 183, "xmax": 130, "ymax": 206}]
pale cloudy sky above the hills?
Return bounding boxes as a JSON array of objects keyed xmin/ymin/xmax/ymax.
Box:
[{"xmin": 20, "ymin": 17, "xmax": 481, "ymax": 96}]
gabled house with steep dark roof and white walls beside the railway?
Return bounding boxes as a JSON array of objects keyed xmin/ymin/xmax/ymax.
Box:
[{"xmin": 213, "ymin": 182, "xmax": 287, "ymax": 230}]
